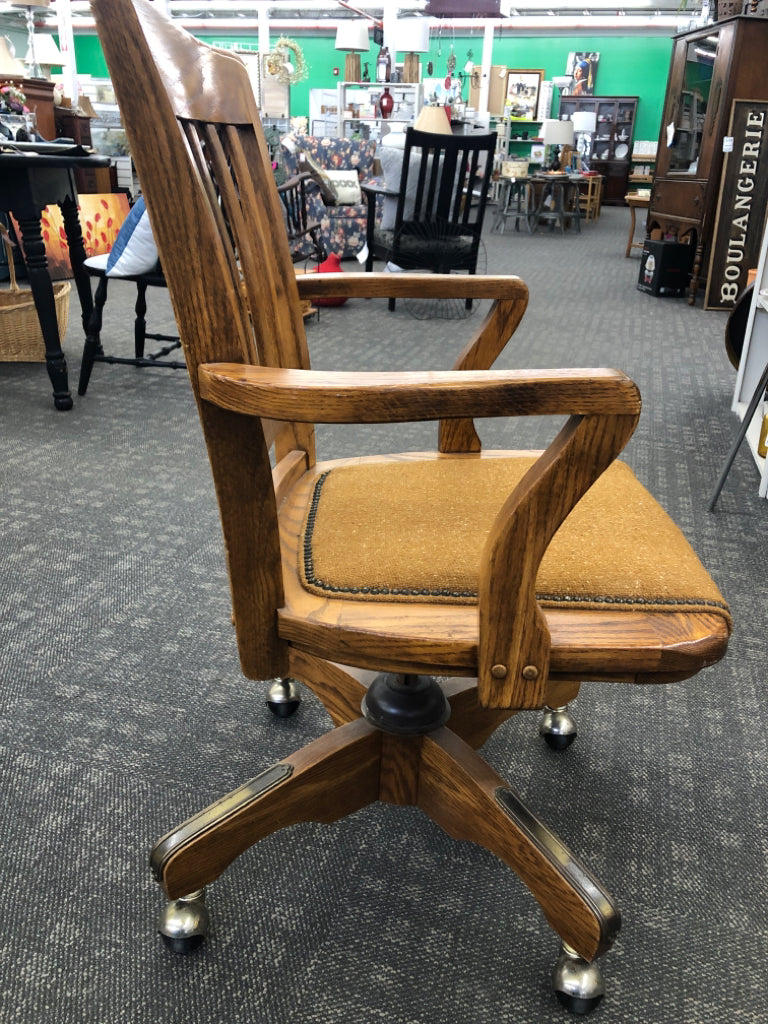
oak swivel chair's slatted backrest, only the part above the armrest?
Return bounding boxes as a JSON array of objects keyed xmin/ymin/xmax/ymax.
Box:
[{"xmin": 94, "ymin": 0, "xmax": 309, "ymax": 393}]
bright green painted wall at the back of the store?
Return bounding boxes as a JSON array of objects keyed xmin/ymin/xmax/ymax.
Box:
[{"xmin": 75, "ymin": 33, "xmax": 672, "ymax": 140}]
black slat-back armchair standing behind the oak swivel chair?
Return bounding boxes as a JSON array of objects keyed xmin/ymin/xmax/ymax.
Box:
[{"xmin": 361, "ymin": 128, "xmax": 496, "ymax": 309}]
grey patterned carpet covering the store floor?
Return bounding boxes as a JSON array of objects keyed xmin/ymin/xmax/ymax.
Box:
[{"xmin": 0, "ymin": 201, "xmax": 768, "ymax": 1024}]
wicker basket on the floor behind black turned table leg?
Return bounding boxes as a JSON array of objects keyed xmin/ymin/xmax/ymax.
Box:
[{"xmin": 0, "ymin": 239, "xmax": 71, "ymax": 362}]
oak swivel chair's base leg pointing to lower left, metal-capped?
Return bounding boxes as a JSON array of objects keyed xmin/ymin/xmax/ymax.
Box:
[{"xmin": 151, "ymin": 719, "xmax": 381, "ymax": 900}]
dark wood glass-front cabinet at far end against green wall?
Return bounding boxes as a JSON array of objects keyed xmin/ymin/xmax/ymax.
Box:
[{"xmin": 560, "ymin": 96, "xmax": 638, "ymax": 206}]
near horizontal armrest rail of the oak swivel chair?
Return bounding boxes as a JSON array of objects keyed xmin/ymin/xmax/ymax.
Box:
[{"xmin": 199, "ymin": 362, "xmax": 640, "ymax": 423}]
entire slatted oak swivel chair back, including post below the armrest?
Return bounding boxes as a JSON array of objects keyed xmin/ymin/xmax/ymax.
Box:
[{"xmin": 93, "ymin": 0, "xmax": 314, "ymax": 679}]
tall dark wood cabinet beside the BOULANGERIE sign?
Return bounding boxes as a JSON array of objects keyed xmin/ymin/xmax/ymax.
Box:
[{"xmin": 647, "ymin": 15, "xmax": 768, "ymax": 305}]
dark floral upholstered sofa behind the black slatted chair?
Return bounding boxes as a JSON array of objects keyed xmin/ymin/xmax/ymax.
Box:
[{"xmin": 281, "ymin": 133, "xmax": 376, "ymax": 259}]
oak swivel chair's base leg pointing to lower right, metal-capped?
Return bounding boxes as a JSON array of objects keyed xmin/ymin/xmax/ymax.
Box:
[{"xmin": 418, "ymin": 728, "xmax": 621, "ymax": 961}]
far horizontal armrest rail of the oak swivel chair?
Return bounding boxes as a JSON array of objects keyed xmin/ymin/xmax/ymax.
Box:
[{"xmin": 296, "ymin": 273, "xmax": 528, "ymax": 301}]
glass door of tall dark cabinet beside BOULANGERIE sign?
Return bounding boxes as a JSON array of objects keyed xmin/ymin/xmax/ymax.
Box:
[{"xmin": 669, "ymin": 35, "xmax": 718, "ymax": 175}]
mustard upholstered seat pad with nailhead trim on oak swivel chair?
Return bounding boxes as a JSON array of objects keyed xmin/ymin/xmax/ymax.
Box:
[{"xmin": 299, "ymin": 455, "xmax": 729, "ymax": 620}]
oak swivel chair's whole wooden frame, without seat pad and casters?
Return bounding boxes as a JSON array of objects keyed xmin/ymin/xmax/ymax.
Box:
[{"xmin": 92, "ymin": 0, "xmax": 728, "ymax": 1007}]
